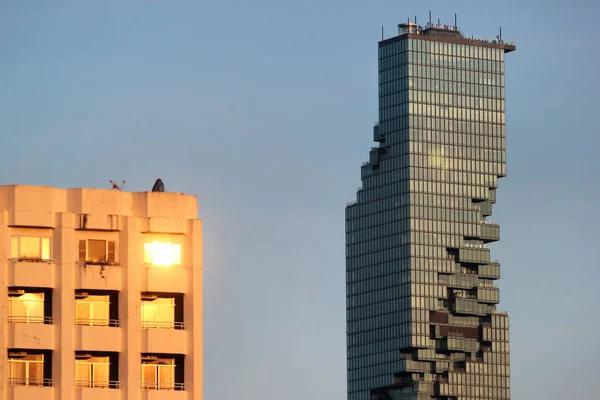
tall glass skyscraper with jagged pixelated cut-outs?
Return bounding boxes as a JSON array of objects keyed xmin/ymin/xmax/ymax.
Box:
[{"xmin": 346, "ymin": 22, "xmax": 515, "ymax": 400}]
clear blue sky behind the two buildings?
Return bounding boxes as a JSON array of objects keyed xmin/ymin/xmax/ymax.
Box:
[{"xmin": 0, "ymin": 0, "xmax": 600, "ymax": 400}]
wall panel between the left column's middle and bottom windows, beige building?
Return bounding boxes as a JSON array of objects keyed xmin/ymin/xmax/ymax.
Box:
[{"xmin": 8, "ymin": 317, "xmax": 54, "ymax": 350}]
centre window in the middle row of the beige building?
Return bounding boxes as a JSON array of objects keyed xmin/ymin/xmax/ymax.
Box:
[{"xmin": 75, "ymin": 290, "xmax": 119, "ymax": 327}]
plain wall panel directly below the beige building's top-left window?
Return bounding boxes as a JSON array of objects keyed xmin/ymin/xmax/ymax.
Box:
[{"xmin": 8, "ymin": 258, "xmax": 55, "ymax": 287}]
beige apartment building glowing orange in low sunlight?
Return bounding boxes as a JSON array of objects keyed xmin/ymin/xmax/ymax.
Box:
[{"xmin": 0, "ymin": 185, "xmax": 202, "ymax": 400}]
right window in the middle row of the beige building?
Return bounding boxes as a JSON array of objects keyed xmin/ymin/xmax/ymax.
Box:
[{"xmin": 141, "ymin": 293, "xmax": 184, "ymax": 329}]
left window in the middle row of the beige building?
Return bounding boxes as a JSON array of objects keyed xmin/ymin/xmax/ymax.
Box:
[{"xmin": 8, "ymin": 288, "xmax": 52, "ymax": 324}]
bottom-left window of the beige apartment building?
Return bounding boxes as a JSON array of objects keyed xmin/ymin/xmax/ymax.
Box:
[{"xmin": 8, "ymin": 350, "xmax": 52, "ymax": 386}]
